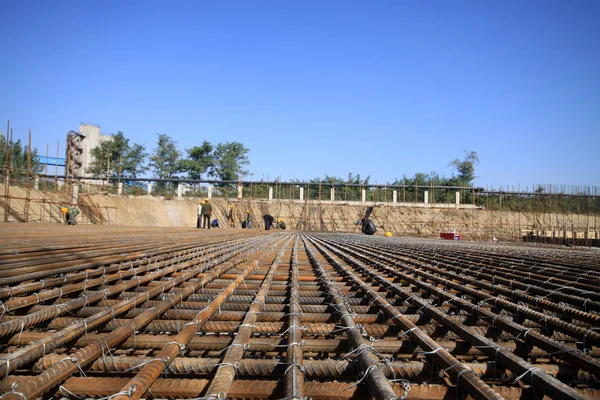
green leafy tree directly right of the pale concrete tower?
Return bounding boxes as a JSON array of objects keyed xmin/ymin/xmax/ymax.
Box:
[{"xmin": 87, "ymin": 131, "xmax": 148, "ymax": 178}]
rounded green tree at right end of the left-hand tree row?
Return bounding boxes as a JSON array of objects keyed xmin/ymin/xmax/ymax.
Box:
[{"xmin": 209, "ymin": 142, "xmax": 250, "ymax": 181}]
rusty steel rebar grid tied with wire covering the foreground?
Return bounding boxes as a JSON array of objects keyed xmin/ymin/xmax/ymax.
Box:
[{"xmin": 0, "ymin": 225, "xmax": 600, "ymax": 400}]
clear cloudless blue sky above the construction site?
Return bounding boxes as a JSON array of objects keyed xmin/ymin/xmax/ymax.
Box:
[{"xmin": 0, "ymin": 0, "xmax": 600, "ymax": 188}]
